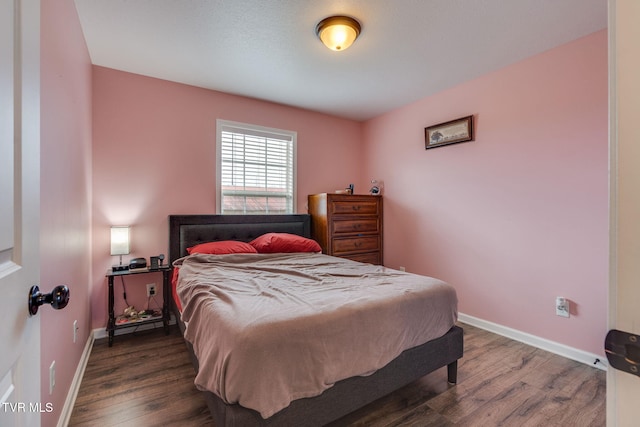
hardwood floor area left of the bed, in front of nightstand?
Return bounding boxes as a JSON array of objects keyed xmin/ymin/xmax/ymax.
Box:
[{"xmin": 69, "ymin": 330, "xmax": 212, "ymax": 427}]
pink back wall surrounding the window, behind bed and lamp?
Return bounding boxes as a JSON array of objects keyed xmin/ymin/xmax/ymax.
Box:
[{"xmin": 91, "ymin": 67, "xmax": 365, "ymax": 328}]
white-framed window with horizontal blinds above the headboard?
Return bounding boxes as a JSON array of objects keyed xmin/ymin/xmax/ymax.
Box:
[{"xmin": 216, "ymin": 120, "xmax": 297, "ymax": 214}]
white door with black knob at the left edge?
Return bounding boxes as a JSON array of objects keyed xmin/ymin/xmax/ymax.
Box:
[{"xmin": 0, "ymin": 0, "xmax": 41, "ymax": 427}]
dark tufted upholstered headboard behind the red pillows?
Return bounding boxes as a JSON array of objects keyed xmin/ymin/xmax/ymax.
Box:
[{"xmin": 169, "ymin": 214, "xmax": 311, "ymax": 263}]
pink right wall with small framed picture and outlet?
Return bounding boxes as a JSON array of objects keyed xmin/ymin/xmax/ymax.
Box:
[{"xmin": 363, "ymin": 31, "xmax": 608, "ymax": 354}]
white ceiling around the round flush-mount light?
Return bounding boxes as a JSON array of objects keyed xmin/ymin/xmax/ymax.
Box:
[{"xmin": 75, "ymin": 0, "xmax": 607, "ymax": 120}]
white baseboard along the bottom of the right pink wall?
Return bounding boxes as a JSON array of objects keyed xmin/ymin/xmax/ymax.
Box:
[{"xmin": 458, "ymin": 313, "xmax": 608, "ymax": 371}]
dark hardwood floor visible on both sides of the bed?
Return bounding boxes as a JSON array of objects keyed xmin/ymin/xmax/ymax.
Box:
[{"xmin": 69, "ymin": 324, "xmax": 606, "ymax": 427}]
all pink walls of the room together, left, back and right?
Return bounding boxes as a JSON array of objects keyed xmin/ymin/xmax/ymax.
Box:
[{"xmin": 33, "ymin": 5, "xmax": 608, "ymax": 426}]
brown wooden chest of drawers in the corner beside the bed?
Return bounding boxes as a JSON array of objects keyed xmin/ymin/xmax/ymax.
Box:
[{"xmin": 308, "ymin": 193, "xmax": 383, "ymax": 265}]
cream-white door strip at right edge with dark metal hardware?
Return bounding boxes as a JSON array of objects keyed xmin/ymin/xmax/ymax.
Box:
[{"xmin": 607, "ymin": 0, "xmax": 640, "ymax": 427}]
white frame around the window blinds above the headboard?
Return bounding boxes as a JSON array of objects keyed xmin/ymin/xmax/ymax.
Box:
[{"xmin": 215, "ymin": 119, "xmax": 298, "ymax": 215}]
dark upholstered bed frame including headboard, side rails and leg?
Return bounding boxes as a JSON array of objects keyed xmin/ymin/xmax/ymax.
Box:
[{"xmin": 169, "ymin": 215, "xmax": 463, "ymax": 427}]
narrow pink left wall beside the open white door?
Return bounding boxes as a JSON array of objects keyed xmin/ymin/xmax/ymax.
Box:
[{"xmin": 38, "ymin": 0, "xmax": 91, "ymax": 426}]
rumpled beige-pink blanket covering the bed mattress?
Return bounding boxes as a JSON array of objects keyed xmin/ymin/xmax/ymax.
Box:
[{"xmin": 175, "ymin": 254, "xmax": 457, "ymax": 418}]
